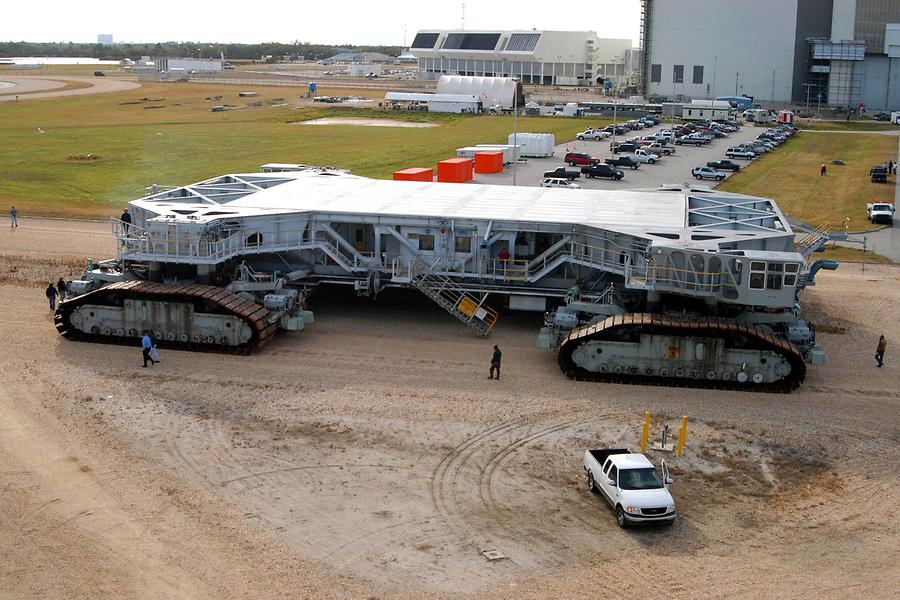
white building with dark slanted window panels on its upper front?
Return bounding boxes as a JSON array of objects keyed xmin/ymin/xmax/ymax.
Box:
[{"xmin": 410, "ymin": 29, "xmax": 632, "ymax": 85}]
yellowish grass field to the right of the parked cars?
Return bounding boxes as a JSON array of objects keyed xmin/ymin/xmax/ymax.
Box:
[{"xmin": 718, "ymin": 132, "xmax": 900, "ymax": 231}]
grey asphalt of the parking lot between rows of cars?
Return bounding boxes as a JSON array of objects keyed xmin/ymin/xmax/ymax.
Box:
[{"xmin": 475, "ymin": 123, "xmax": 764, "ymax": 190}]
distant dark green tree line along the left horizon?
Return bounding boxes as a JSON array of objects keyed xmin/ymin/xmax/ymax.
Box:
[{"xmin": 0, "ymin": 41, "xmax": 403, "ymax": 60}]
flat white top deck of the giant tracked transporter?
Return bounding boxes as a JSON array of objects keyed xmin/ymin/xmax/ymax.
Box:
[{"xmin": 131, "ymin": 168, "xmax": 793, "ymax": 248}]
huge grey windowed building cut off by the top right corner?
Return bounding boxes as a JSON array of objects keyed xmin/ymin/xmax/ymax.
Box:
[{"xmin": 641, "ymin": 0, "xmax": 900, "ymax": 109}]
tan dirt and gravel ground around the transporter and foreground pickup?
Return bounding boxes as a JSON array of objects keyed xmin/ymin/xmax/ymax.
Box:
[{"xmin": 0, "ymin": 219, "xmax": 900, "ymax": 598}]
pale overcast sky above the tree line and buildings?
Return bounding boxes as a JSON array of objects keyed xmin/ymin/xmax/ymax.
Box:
[{"xmin": 0, "ymin": 0, "xmax": 640, "ymax": 46}]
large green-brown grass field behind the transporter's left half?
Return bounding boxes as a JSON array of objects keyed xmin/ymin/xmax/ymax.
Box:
[{"xmin": 0, "ymin": 83, "xmax": 603, "ymax": 218}]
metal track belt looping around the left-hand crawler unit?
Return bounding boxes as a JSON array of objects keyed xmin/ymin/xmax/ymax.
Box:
[{"xmin": 54, "ymin": 280, "xmax": 278, "ymax": 354}]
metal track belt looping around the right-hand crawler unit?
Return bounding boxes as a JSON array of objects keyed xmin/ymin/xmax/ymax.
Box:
[{"xmin": 557, "ymin": 313, "xmax": 806, "ymax": 393}]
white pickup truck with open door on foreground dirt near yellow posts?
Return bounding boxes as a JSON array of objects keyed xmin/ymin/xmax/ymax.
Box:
[{"xmin": 584, "ymin": 448, "xmax": 675, "ymax": 528}]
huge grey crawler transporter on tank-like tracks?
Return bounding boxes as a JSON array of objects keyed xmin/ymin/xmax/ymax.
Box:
[{"xmin": 56, "ymin": 165, "xmax": 837, "ymax": 391}]
